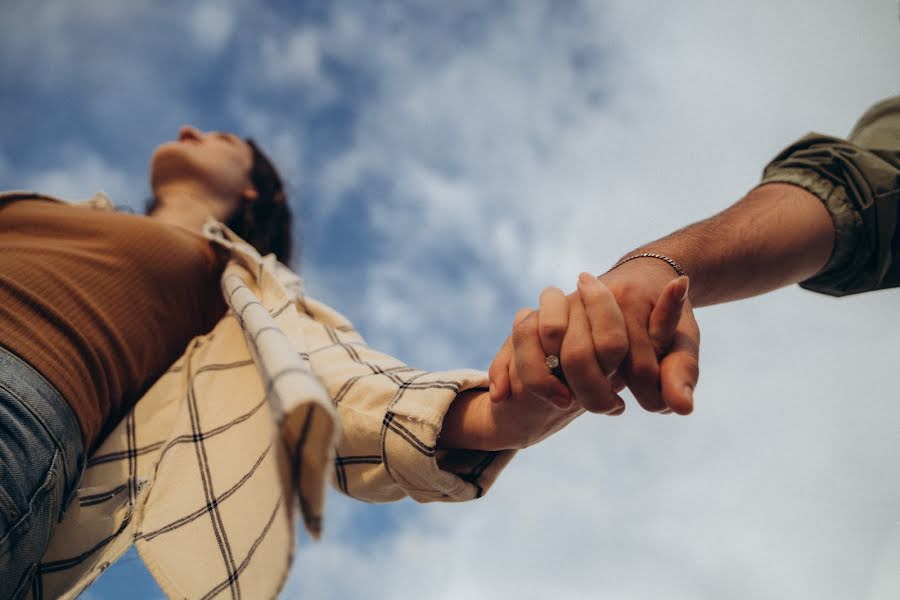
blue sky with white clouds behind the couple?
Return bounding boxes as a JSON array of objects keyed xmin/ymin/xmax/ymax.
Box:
[{"xmin": 0, "ymin": 0, "xmax": 900, "ymax": 600}]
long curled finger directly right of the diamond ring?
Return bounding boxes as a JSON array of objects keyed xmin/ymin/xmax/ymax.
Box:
[{"xmin": 560, "ymin": 294, "xmax": 619, "ymax": 413}]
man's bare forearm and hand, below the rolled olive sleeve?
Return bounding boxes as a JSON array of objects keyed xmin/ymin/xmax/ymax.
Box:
[{"xmin": 584, "ymin": 183, "xmax": 834, "ymax": 414}]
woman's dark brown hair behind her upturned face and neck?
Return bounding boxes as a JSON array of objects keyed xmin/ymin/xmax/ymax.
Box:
[{"xmin": 145, "ymin": 138, "xmax": 293, "ymax": 265}]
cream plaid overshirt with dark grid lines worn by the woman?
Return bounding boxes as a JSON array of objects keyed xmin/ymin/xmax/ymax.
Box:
[{"xmin": 17, "ymin": 198, "xmax": 514, "ymax": 600}]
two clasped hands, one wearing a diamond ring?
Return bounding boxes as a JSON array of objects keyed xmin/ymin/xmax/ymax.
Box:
[{"xmin": 442, "ymin": 258, "xmax": 700, "ymax": 450}]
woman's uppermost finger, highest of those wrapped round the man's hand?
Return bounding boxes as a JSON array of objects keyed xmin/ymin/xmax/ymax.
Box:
[{"xmin": 578, "ymin": 273, "xmax": 628, "ymax": 376}]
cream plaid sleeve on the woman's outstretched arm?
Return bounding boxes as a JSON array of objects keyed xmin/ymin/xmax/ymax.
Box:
[{"xmin": 290, "ymin": 297, "xmax": 515, "ymax": 502}]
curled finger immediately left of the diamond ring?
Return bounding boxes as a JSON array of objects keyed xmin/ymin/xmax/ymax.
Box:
[{"xmin": 512, "ymin": 312, "xmax": 572, "ymax": 408}]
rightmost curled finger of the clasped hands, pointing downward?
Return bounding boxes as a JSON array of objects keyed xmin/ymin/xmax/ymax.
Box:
[{"xmin": 660, "ymin": 307, "xmax": 700, "ymax": 415}]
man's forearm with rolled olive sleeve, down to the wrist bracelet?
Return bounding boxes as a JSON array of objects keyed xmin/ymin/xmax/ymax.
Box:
[{"xmin": 624, "ymin": 97, "xmax": 900, "ymax": 306}]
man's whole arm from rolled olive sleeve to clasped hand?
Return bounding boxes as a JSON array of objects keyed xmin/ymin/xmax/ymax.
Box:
[{"xmin": 491, "ymin": 97, "xmax": 900, "ymax": 414}]
